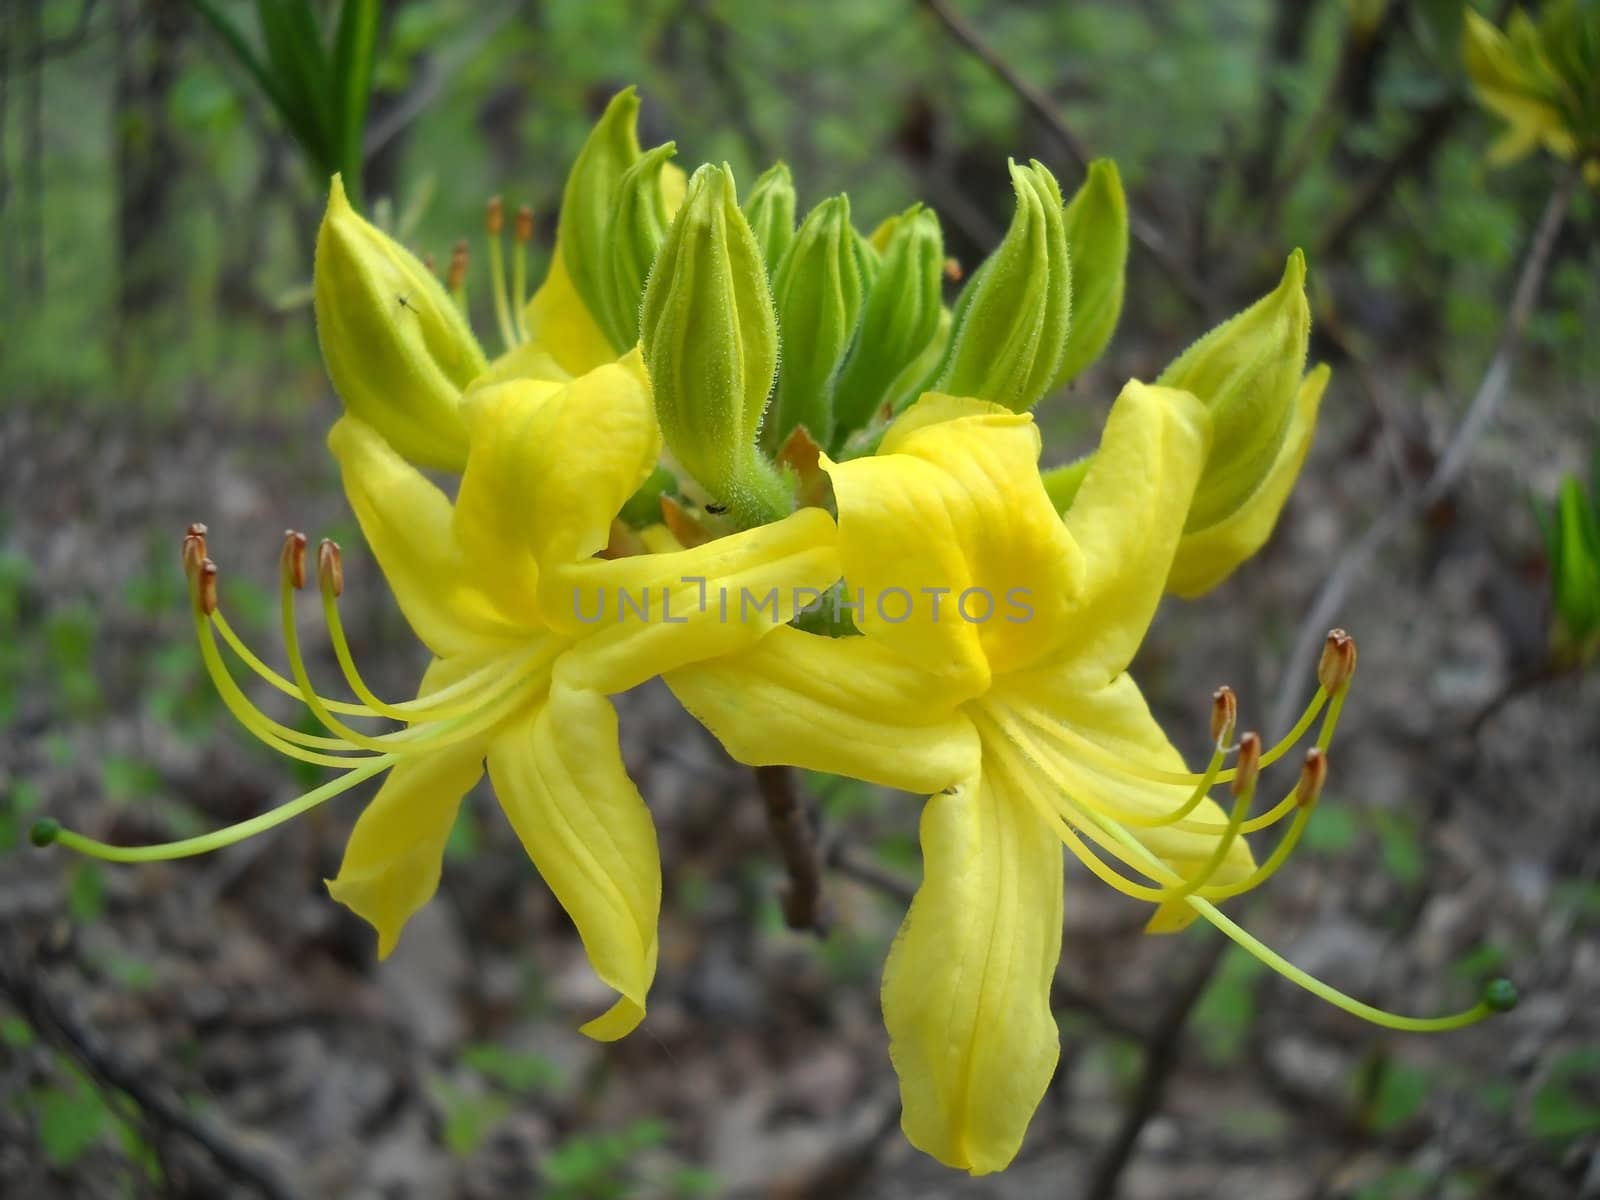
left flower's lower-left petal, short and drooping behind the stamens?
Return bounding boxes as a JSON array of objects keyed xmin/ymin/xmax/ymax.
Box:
[{"xmin": 326, "ymin": 659, "xmax": 483, "ymax": 958}]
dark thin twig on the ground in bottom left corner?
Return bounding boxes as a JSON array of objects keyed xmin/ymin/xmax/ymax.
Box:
[{"xmin": 0, "ymin": 958, "xmax": 298, "ymax": 1200}]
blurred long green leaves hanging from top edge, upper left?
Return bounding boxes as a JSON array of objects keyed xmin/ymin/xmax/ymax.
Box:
[{"xmin": 190, "ymin": 0, "xmax": 378, "ymax": 205}]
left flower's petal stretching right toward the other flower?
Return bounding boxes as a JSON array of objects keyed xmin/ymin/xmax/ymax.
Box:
[{"xmin": 541, "ymin": 509, "xmax": 838, "ymax": 693}]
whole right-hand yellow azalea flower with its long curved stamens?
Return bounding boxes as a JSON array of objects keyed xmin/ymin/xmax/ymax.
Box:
[{"xmin": 666, "ymin": 392, "xmax": 1514, "ymax": 1174}]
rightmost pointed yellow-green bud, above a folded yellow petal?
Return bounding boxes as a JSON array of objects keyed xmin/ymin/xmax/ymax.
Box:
[{"xmin": 1155, "ymin": 250, "xmax": 1310, "ymax": 533}]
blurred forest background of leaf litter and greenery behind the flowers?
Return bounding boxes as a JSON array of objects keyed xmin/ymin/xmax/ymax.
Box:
[{"xmin": 0, "ymin": 0, "xmax": 1600, "ymax": 1200}]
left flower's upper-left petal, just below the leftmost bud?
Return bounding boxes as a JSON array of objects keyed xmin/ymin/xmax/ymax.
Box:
[{"xmin": 328, "ymin": 418, "xmax": 518, "ymax": 658}]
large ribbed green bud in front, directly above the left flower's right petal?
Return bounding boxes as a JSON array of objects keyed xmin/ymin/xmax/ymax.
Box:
[{"xmin": 640, "ymin": 163, "xmax": 792, "ymax": 526}]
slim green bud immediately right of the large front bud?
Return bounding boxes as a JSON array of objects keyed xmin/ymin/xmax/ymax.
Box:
[{"xmin": 762, "ymin": 195, "xmax": 866, "ymax": 451}]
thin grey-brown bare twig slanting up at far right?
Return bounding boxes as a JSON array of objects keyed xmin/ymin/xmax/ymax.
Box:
[{"xmin": 1270, "ymin": 170, "xmax": 1578, "ymax": 733}]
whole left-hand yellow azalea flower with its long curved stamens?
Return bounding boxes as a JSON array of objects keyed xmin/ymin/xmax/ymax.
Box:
[{"xmin": 40, "ymin": 355, "xmax": 838, "ymax": 1040}]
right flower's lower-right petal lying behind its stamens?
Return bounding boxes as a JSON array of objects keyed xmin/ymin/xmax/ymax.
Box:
[{"xmin": 994, "ymin": 672, "xmax": 1248, "ymax": 931}]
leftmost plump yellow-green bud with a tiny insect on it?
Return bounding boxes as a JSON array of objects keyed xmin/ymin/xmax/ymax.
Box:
[{"xmin": 314, "ymin": 176, "xmax": 488, "ymax": 470}]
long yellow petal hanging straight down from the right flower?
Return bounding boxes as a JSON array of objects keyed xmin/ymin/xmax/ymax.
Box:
[{"xmin": 883, "ymin": 778, "xmax": 1061, "ymax": 1174}]
